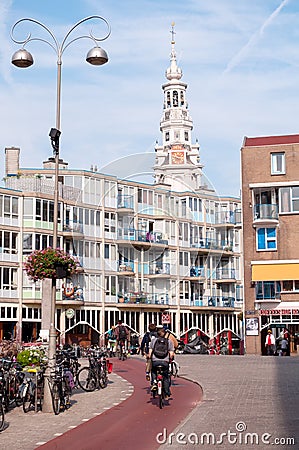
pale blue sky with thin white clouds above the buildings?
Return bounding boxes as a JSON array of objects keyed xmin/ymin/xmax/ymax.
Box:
[{"xmin": 0, "ymin": 0, "xmax": 299, "ymax": 195}]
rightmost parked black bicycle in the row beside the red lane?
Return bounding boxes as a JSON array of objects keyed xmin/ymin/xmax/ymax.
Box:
[{"xmin": 78, "ymin": 351, "xmax": 109, "ymax": 392}]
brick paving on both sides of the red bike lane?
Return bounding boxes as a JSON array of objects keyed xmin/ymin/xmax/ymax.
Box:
[{"xmin": 0, "ymin": 355, "xmax": 299, "ymax": 450}]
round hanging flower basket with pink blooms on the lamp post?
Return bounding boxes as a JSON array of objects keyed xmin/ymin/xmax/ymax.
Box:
[{"xmin": 24, "ymin": 247, "xmax": 79, "ymax": 281}]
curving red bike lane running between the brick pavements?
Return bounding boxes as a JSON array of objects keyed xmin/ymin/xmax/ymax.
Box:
[{"xmin": 38, "ymin": 358, "xmax": 202, "ymax": 450}]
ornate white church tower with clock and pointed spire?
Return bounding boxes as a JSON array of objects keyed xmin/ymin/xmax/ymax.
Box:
[{"xmin": 154, "ymin": 23, "xmax": 203, "ymax": 192}]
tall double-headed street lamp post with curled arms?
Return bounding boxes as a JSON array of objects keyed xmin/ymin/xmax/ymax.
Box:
[{"xmin": 11, "ymin": 15, "xmax": 111, "ymax": 412}]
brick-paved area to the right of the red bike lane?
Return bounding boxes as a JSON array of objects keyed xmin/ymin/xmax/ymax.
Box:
[{"xmin": 159, "ymin": 355, "xmax": 299, "ymax": 450}]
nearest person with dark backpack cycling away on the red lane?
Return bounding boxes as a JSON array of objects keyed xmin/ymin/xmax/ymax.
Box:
[{"xmin": 149, "ymin": 327, "xmax": 174, "ymax": 400}]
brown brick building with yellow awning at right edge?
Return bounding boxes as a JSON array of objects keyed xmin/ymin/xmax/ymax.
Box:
[{"xmin": 241, "ymin": 135, "xmax": 299, "ymax": 354}]
